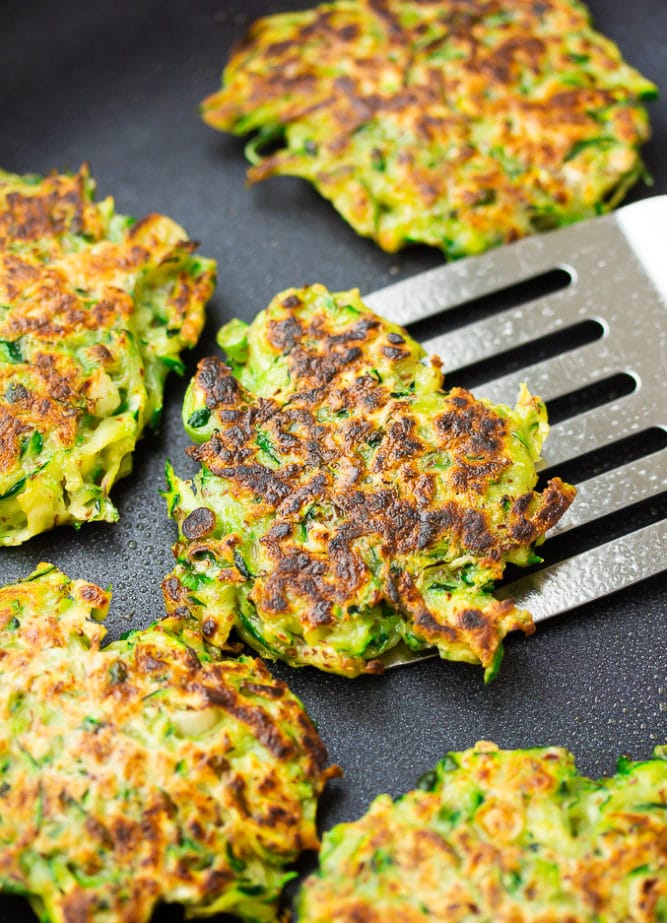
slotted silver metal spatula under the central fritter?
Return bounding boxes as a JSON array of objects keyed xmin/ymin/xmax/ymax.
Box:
[{"xmin": 365, "ymin": 196, "xmax": 667, "ymax": 666}]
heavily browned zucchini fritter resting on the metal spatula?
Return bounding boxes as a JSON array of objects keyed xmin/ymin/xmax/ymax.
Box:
[{"xmin": 163, "ymin": 285, "xmax": 574, "ymax": 678}]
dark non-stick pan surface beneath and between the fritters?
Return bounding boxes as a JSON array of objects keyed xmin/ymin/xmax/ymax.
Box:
[{"xmin": 0, "ymin": 0, "xmax": 667, "ymax": 923}]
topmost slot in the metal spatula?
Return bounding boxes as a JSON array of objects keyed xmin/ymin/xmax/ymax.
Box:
[{"xmin": 406, "ymin": 267, "xmax": 572, "ymax": 341}]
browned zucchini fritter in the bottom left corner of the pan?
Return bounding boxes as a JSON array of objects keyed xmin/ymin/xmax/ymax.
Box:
[{"xmin": 0, "ymin": 565, "xmax": 333, "ymax": 923}]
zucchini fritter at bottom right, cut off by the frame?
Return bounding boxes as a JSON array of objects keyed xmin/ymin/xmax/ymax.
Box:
[{"xmin": 297, "ymin": 743, "xmax": 667, "ymax": 923}]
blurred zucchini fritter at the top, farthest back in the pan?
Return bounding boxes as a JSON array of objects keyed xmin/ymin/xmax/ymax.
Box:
[{"xmin": 202, "ymin": 0, "xmax": 656, "ymax": 257}]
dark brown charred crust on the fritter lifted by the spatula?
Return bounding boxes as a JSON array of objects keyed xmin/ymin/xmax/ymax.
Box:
[{"xmin": 180, "ymin": 295, "xmax": 574, "ymax": 665}]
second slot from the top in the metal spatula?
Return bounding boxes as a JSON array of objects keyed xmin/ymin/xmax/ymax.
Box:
[{"xmin": 447, "ymin": 320, "xmax": 605, "ymax": 388}]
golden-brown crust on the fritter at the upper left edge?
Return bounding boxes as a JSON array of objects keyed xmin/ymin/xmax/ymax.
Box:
[{"xmin": 0, "ymin": 165, "xmax": 212, "ymax": 484}]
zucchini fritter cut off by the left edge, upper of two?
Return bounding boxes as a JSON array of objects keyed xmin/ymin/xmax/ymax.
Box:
[{"xmin": 0, "ymin": 167, "xmax": 215, "ymax": 545}]
